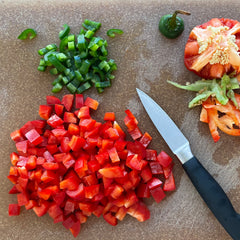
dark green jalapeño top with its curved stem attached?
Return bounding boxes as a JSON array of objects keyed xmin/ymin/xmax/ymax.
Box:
[{"xmin": 158, "ymin": 10, "xmax": 191, "ymax": 39}]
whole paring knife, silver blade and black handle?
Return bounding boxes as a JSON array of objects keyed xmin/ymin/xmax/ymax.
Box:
[{"xmin": 137, "ymin": 89, "xmax": 240, "ymax": 240}]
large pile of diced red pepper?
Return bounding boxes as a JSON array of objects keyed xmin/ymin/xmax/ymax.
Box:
[{"xmin": 8, "ymin": 94, "xmax": 175, "ymax": 237}]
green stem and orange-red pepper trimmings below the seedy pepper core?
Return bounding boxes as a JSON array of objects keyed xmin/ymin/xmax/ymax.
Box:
[{"xmin": 168, "ymin": 75, "xmax": 240, "ymax": 142}]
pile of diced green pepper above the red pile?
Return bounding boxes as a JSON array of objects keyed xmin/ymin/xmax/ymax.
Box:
[{"xmin": 38, "ymin": 19, "xmax": 117, "ymax": 93}]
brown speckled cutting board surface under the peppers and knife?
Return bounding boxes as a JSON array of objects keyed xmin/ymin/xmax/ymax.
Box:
[{"xmin": 0, "ymin": 0, "xmax": 240, "ymax": 240}]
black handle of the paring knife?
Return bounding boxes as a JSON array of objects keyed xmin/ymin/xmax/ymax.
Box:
[{"xmin": 183, "ymin": 157, "xmax": 240, "ymax": 240}]
